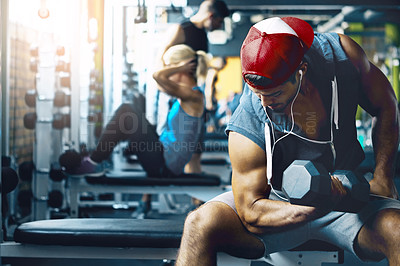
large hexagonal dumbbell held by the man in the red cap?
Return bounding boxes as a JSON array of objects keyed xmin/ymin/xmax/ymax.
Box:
[{"xmin": 282, "ymin": 160, "xmax": 370, "ymax": 212}]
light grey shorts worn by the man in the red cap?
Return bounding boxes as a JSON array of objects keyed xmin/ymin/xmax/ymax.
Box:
[{"xmin": 208, "ymin": 191, "xmax": 400, "ymax": 260}]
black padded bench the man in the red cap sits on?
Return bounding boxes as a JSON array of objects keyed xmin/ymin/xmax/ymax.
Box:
[{"xmin": 1, "ymin": 218, "xmax": 343, "ymax": 266}]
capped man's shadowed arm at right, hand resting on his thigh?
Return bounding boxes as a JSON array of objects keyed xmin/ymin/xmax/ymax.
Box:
[{"xmin": 340, "ymin": 35, "xmax": 399, "ymax": 198}]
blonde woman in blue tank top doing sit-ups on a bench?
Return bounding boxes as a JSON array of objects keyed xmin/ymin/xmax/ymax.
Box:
[{"xmin": 70, "ymin": 44, "xmax": 208, "ymax": 183}]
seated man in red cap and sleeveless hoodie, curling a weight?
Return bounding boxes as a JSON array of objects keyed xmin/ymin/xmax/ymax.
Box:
[{"xmin": 177, "ymin": 17, "xmax": 400, "ymax": 265}]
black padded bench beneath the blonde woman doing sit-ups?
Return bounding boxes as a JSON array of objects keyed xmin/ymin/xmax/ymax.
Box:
[{"xmin": 67, "ymin": 170, "xmax": 231, "ymax": 218}]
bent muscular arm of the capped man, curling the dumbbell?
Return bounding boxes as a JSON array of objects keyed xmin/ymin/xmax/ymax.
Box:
[{"xmin": 229, "ymin": 132, "xmax": 320, "ymax": 234}]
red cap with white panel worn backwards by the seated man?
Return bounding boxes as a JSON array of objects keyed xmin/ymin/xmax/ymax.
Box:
[{"xmin": 240, "ymin": 17, "xmax": 314, "ymax": 90}]
